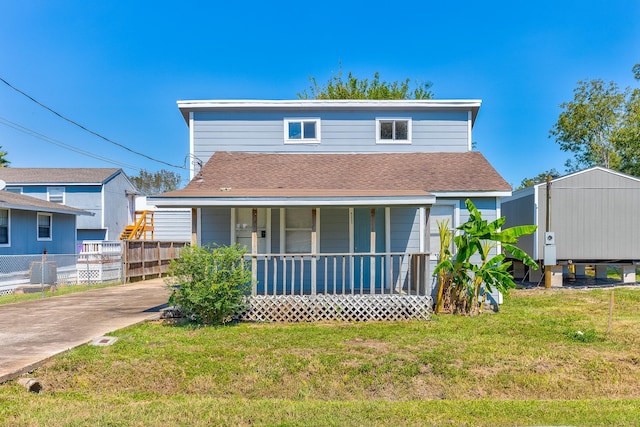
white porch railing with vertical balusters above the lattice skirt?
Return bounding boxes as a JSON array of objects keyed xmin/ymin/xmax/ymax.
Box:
[{"xmin": 245, "ymin": 252, "xmax": 431, "ymax": 295}]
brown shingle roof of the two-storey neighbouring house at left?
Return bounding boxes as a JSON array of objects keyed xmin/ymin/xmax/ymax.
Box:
[{"xmin": 0, "ymin": 167, "xmax": 120, "ymax": 185}]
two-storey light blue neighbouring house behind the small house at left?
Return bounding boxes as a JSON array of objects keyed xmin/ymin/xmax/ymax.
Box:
[{"xmin": 0, "ymin": 167, "xmax": 137, "ymax": 242}]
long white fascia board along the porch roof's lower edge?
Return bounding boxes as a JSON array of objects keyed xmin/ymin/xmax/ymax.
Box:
[{"xmin": 147, "ymin": 196, "xmax": 436, "ymax": 207}]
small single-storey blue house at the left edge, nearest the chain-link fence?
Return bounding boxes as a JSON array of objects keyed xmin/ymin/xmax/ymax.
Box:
[{"xmin": 0, "ymin": 190, "xmax": 91, "ymax": 255}]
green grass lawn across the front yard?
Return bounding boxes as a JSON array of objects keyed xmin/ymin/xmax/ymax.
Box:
[{"xmin": 0, "ymin": 287, "xmax": 640, "ymax": 426}]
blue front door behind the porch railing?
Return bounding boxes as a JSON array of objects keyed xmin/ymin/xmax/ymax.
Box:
[{"xmin": 352, "ymin": 208, "xmax": 385, "ymax": 293}]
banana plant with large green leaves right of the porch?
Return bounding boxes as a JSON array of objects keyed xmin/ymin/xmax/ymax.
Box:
[{"xmin": 433, "ymin": 200, "xmax": 538, "ymax": 315}]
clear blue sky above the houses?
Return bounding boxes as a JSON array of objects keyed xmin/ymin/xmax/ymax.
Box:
[{"xmin": 0, "ymin": 0, "xmax": 640, "ymax": 186}]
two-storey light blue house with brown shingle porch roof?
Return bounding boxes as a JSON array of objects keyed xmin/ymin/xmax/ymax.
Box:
[{"xmin": 149, "ymin": 100, "xmax": 511, "ymax": 320}]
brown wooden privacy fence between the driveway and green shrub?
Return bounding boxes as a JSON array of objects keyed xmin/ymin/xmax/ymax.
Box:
[{"xmin": 122, "ymin": 240, "xmax": 189, "ymax": 283}]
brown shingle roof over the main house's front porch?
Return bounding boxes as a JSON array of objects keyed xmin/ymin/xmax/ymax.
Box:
[{"xmin": 160, "ymin": 152, "xmax": 511, "ymax": 197}]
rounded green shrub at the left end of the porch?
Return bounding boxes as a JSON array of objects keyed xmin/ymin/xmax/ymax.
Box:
[{"xmin": 167, "ymin": 245, "xmax": 251, "ymax": 325}]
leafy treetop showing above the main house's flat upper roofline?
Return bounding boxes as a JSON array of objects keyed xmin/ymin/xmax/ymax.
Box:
[{"xmin": 298, "ymin": 66, "xmax": 433, "ymax": 99}]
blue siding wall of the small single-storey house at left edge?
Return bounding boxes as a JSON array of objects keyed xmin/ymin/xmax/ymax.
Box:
[{"xmin": 0, "ymin": 209, "xmax": 76, "ymax": 255}]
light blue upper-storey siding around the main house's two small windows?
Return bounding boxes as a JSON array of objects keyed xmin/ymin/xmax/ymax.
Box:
[{"xmin": 193, "ymin": 110, "xmax": 469, "ymax": 161}]
